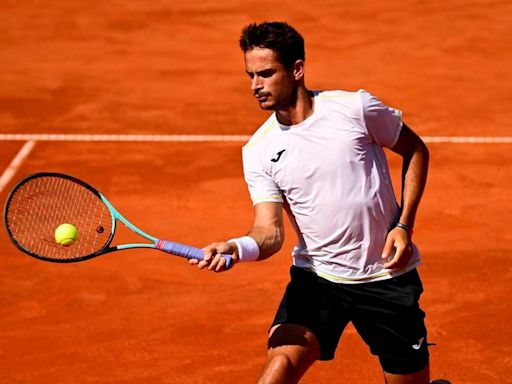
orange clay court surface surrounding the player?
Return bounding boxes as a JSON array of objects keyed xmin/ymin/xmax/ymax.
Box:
[{"xmin": 0, "ymin": 0, "xmax": 512, "ymax": 384}]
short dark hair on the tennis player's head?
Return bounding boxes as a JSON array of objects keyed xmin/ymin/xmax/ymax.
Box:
[{"xmin": 240, "ymin": 22, "xmax": 306, "ymax": 69}]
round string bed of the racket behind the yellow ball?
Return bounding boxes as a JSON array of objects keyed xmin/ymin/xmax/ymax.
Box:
[{"xmin": 6, "ymin": 176, "xmax": 112, "ymax": 261}]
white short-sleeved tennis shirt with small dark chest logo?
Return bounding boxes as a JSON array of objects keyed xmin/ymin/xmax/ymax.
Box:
[{"xmin": 242, "ymin": 90, "xmax": 419, "ymax": 283}]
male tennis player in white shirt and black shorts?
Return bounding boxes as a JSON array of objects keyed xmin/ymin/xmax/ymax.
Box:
[{"xmin": 191, "ymin": 22, "xmax": 430, "ymax": 384}]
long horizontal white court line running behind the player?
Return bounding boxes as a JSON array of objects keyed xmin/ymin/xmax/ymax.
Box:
[{"xmin": 0, "ymin": 133, "xmax": 512, "ymax": 144}]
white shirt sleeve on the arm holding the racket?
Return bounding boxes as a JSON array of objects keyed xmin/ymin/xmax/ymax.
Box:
[{"xmin": 242, "ymin": 147, "xmax": 283, "ymax": 205}]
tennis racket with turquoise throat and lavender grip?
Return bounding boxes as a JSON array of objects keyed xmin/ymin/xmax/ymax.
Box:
[{"xmin": 4, "ymin": 173, "xmax": 231, "ymax": 268}]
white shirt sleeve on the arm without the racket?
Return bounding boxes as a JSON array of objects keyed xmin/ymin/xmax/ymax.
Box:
[{"xmin": 360, "ymin": 90, "xmax": 402, "ymax": 148}]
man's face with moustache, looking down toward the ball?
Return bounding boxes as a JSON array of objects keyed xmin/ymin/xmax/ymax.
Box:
[{"xmin": 244, "ymin": 48, "xmax": 297, "ymax": 110}]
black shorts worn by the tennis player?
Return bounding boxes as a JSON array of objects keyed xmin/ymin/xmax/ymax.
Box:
[{"xmin": 272, "ymin": 267, "xmax": 429, "ymax": 374}]
